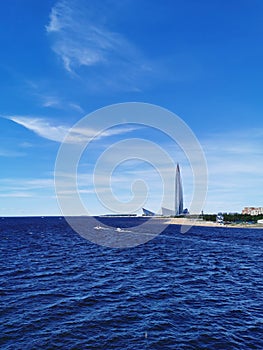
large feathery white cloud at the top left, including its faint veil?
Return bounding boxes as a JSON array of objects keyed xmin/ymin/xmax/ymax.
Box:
[{"xmin": 46, "ymin": 0, "xmax": 150, "ymax": 89}]
